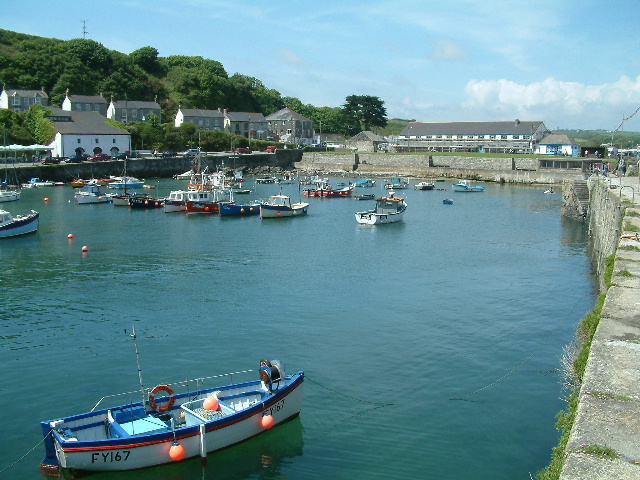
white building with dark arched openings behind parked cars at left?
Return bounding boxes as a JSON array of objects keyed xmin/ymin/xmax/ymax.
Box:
[{"xmin": 47, "ymin": 107, "xmax": 131, "ymax": 157}]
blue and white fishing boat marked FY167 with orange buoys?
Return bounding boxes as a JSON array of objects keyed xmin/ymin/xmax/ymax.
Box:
[{"xmin": 40, "ymin": 328, "xmax": 304, "ymax": 478}]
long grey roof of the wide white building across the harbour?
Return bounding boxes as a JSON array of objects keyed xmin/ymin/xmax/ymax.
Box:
[{"xmin": 400, "ymin": 120, "xmax": 543, "ymax": 137}]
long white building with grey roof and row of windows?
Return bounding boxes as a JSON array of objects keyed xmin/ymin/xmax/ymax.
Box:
[{"xmin": 392, "ymin": 119, "xmax": 548, "ymax": 153}]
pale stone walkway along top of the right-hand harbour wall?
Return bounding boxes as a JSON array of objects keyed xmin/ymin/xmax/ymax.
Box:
[{"xmin": 560, "ymin": 176, "xmax": 640, "ymax": 480}]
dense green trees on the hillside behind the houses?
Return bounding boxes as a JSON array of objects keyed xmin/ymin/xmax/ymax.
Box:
[{"xmin": 0, "ymin": 29, "xmax": 387, "ymax": 147}]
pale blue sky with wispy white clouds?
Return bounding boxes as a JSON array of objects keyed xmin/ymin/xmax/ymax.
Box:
[{"xmin": 0, "ymin": 0, "xmax": 640, "ymax": 131}]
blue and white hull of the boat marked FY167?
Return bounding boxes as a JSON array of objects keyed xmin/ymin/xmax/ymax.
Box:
[{"xmin": 41, "ymin": 372, "xmax": 304, "ymax": 472}]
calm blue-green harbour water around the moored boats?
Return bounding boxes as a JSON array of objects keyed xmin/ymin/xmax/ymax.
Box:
[{"xmin": 0, "ymin": 179, "xmax": 595, "ymax": 480}]
